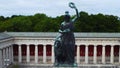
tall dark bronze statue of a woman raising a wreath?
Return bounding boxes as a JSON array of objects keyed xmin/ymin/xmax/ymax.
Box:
[{"xmin": 54, "ymin": 2, "xmax": 79, "ymax": 66}]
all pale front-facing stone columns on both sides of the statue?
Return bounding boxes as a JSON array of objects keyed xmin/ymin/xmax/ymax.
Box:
[{"xmin": 14, "ymin": 45, "xmax": 120, "ymax": 64}]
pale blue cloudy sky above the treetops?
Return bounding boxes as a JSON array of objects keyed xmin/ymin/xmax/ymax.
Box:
[{"xmin": 0, "ymin": 0, "xmax": 120, "ymax": 17}]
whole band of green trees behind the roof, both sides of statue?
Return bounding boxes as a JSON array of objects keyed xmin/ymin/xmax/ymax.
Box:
[{"xmin": 0, "ymin": 11, "xmax": 120, "ymax": 32}]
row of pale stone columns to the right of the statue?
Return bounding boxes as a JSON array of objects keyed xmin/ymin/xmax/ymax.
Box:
[{"xmin": 77, "ymin": 45, "xmax": 120, "ymax": 64}]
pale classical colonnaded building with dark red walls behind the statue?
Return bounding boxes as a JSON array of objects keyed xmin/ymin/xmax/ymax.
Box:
[{"xmin": 0, "ymin": 32, "xmax": 120, "ymax": 68}]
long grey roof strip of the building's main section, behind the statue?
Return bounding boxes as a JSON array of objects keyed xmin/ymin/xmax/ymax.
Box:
[{"xmin": 3, "ymin": 32, "xmax": 120, "ymax": 38}]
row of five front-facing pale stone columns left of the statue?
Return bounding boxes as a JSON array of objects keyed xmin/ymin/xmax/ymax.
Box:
[{"xmin": 18, "ymin": 45, "xmax": 55, "ymax": 63}]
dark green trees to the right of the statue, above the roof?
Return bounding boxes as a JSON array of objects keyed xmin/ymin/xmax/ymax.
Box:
[{"xmin": 75, "ymin": 12, "xmax": 120, "ymax": 32}]
